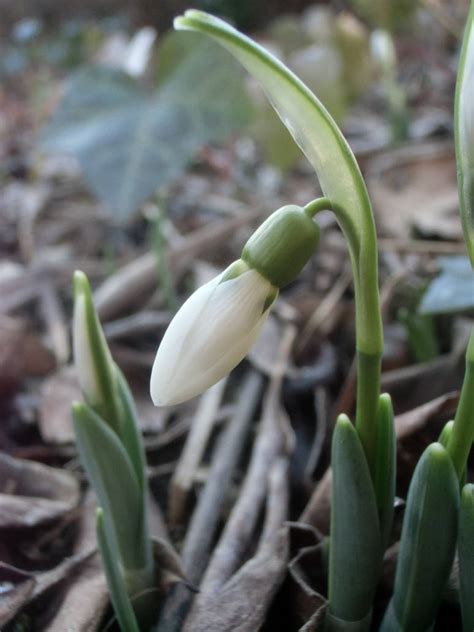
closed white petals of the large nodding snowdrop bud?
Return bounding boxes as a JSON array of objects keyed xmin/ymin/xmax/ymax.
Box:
[{"xmin": 150, "ymin": 260, "xmax": 278, "ymax": 406}]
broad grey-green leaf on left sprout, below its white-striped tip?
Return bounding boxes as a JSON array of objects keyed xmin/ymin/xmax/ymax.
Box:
[{"xmin": 72, "ymin": 403, "xmax": 146, "ymax": 569}]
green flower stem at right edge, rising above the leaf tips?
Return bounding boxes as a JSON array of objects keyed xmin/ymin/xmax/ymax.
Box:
[{"xmin": 447, "ymin": 327, "xmax": 474, "ymax": 478}]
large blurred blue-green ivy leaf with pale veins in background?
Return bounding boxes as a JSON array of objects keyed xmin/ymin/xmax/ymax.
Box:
[{"xmin": 43, "ymin": 33, "xmax": 248, "ymax": 219}]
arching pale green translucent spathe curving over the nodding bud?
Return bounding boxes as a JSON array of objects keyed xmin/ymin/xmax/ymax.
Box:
[{"xmin": 174, "ymin": 10, "xmax": 382, "ymax": 354}]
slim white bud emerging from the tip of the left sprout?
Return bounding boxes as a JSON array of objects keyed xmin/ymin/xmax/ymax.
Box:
[{"xmin": 73, "ymin": 294, "xmax": 100, "ymax": 402}]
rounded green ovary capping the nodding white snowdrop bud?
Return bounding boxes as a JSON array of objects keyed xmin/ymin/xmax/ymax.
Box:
[{"xmin": 242, "ymin": 204, "xmax": 319, "ymax": 288}]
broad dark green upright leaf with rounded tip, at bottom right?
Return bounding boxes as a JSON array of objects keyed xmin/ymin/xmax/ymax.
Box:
[{"xmin": 380, "ymin": 443, "xmax": 459, "ymax": 632}]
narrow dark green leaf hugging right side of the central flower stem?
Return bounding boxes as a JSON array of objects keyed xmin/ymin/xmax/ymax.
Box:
[{"xmin": 374, "ymin": 393, "xmax": 397, "ymax": 550}]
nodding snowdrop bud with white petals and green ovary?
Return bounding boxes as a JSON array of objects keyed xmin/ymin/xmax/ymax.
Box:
[{"xmin": 150, "ymin": 206, "xmax": 319, "ymax": 406}]
